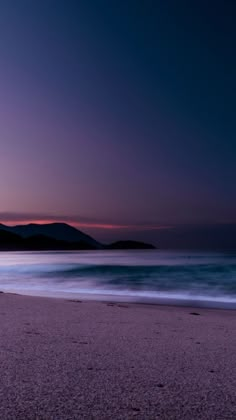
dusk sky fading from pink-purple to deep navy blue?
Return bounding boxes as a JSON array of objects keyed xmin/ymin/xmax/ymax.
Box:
[{"xmin": 0, "ymin": 0, "xmax": 236, "ymax": 240}]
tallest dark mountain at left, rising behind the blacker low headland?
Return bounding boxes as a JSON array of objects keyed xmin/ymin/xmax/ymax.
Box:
[{"xmin": 0, "ymin": 223, "xmax": 100, "ymax": 249}]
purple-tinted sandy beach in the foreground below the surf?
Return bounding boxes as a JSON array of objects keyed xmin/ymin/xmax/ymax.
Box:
[{"xmin": 0, "ymin": 294, "xmax": 236, "ymax": 420}]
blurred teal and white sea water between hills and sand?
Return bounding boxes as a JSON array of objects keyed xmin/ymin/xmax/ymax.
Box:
[{"xmin": 0, "ymin": 250, "xmax": 236, "ymax": 308}]
